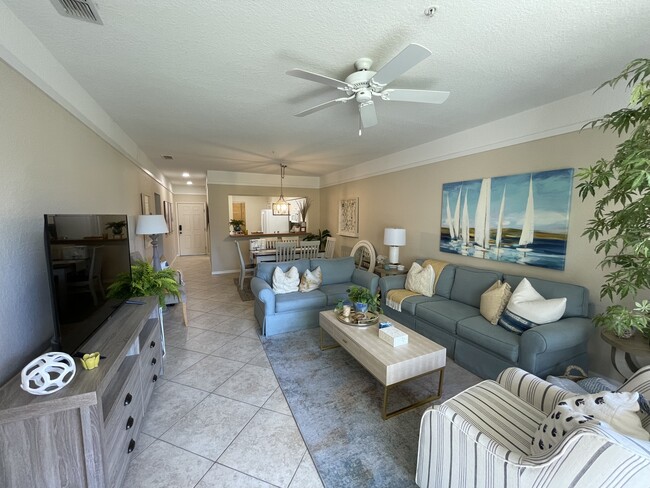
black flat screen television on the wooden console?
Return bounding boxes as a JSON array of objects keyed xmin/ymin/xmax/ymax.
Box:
[{"xmin": 45, "ymin": 214, "xmax": 131, "ymax": 354}]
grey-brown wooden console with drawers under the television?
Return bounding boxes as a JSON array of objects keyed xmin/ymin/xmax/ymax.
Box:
[{"xmin": 0, "ymin": 297, "xmax": 162, "ymax": 488}]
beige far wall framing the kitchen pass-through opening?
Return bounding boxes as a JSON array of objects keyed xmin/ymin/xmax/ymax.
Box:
[{"xmin": 208, "ymin": 185, "xmax": 321, "ymax": 273}]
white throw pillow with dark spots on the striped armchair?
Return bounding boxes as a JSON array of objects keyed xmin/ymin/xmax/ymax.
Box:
[{"xmin": 531, "ymin": 392, "xmax": 650, "ymax": 454}]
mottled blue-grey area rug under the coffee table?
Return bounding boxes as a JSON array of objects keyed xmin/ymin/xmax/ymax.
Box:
[{"xmin": 262, "ymin": 328, "xmax": 481, "ymax": 488}]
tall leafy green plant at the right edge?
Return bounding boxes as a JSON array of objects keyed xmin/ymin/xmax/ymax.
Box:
[{"xmin": 576, "ymin": 59, "xmax": 650, "ymax": 336}]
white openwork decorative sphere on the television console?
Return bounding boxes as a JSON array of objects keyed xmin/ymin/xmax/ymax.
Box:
[{"xmin": 20, "ymin": 352, "xmax": 77, "ymax": 395}]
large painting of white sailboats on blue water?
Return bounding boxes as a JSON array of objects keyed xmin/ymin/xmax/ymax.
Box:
[{"xmin": 440, "ymin": 168, "xmax": 573, "ymax": 270}]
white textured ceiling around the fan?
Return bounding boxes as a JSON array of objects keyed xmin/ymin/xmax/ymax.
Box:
[{"xmin": 2, "ymin": 0, "xmax": 650, "ymax": 189}]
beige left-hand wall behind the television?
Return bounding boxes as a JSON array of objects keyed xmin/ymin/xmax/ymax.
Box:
[{"xmin": 0, "ymin": 61, "xmax": 176, "ymax": 384}]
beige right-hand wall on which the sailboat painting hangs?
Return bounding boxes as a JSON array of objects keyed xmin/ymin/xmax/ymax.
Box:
[{"xmin": 321, "ymin": 130, "xmax": 617, "ymax": 377}]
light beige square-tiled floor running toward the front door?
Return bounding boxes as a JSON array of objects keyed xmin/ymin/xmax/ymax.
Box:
[{"xmin": 124, "ymin": 256, "xmax": 323, "ymax": 488}]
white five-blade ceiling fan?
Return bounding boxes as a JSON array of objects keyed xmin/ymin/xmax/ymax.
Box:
[{"xmin": 287, "ymin": 44, "xmax": 449, "ymax": 135}]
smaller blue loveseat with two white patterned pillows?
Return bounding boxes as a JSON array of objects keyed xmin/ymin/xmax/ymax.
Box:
[{"xmin": 251, "ymin": 257, "xmax": 379, "ymax": 336}]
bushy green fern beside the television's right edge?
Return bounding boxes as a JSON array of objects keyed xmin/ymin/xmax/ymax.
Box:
[{"xmin": 106, "ymin": 261, "xmax": 180, "ymax": 307}]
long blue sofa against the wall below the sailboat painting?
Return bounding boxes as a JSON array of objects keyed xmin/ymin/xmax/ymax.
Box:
[{"xmin": 379, "ymin": 260, "xmax": 593, "ymax": 379}]
